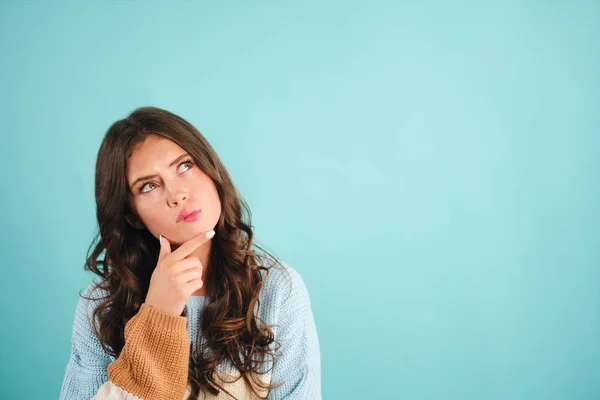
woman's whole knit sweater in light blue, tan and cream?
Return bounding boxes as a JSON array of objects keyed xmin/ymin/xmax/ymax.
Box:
[{"xmin": 59, "ymin": 257, "xmax": 321, "ymax": 400}]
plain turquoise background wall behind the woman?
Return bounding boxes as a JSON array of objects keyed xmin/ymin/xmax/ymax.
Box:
[{"xmin": 0, "ymin": 1, "xmax": 600, "ymax": 400}]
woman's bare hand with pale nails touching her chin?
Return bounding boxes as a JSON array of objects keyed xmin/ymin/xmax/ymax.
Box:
[{"xmin": 145, "ymin": 229, "xmax": 215, "ymax": 316}]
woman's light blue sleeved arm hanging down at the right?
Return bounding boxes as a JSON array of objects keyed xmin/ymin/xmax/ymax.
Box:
[{"xmin": 268, "ymin": 268, "xmax": 321, "ymax": 400}]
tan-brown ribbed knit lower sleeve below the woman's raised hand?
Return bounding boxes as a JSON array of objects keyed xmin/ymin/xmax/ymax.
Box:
[{"xmin": 107, "ymin": 303, "xmax": 190, "ymax": 400}]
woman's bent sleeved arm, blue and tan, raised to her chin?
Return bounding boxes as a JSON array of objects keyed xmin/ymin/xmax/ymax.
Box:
[{"xmin": 60, "ymin": 284, "xmax": 189, "ymax": 400}]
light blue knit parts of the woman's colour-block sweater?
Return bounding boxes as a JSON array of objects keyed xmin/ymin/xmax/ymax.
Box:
[{"xmin": 60, "ymin": 262, "xmax": 321, "ymax": 400}]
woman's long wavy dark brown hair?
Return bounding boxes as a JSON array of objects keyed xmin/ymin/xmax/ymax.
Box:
[{"xmin": 82, "ymin": 107, "xmax": 281, "ymax": 400}]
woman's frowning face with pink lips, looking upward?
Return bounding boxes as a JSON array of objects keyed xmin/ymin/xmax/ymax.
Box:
[{"xmin": 126, "ymin": 135, "xmax": 221, "ymax": 245}]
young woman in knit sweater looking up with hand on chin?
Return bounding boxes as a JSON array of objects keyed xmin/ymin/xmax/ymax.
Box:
[{"xmin": 60, "ymin": 107, "xmax": 321, "ymax": 400}]
